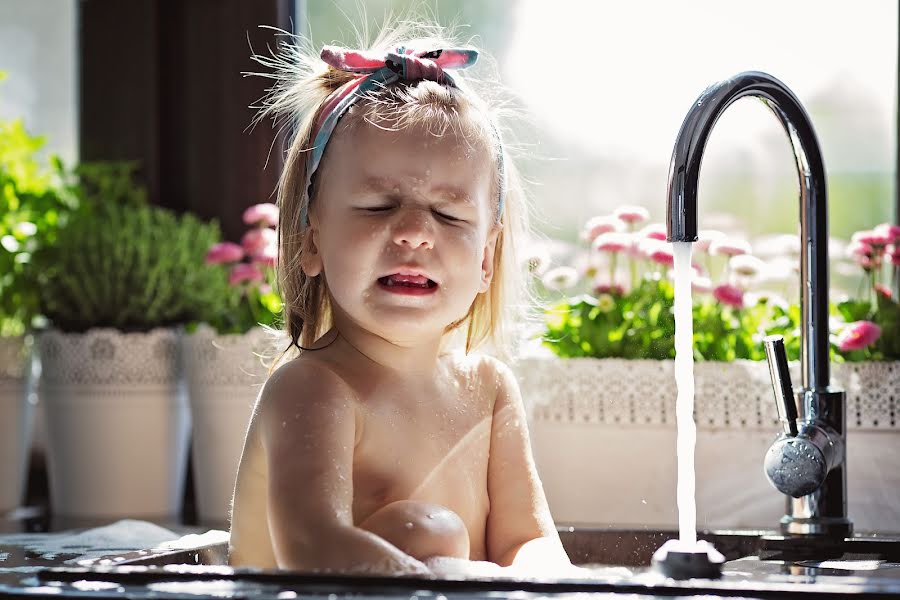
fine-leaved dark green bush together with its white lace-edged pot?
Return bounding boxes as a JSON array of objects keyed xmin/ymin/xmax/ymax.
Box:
[{"xmin": 38, "ymin": 164, "xmax": 232, "ymax": 519}]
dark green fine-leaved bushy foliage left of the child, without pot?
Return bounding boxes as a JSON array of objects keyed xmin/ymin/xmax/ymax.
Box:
[{"xmin": 40, "ymin": 164, "xmax": 228, "ymax": 331}]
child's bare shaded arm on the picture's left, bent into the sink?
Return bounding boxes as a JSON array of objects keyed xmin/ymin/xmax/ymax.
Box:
[{"xmin": 258, "ymin": 361, "xmax": 429, "ymax": 573}]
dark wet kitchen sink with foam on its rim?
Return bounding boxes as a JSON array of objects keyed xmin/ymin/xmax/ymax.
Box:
[{"xmin": 0, "ymin": 527, "xmax": 900, "ymax": 600}]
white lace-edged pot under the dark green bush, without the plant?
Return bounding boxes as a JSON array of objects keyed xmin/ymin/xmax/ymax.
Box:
[{"xmin": 38, "ymin": 329, "xmax": 190, "ymax": 519}]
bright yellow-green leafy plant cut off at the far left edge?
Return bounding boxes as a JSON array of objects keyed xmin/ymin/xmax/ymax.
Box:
[{"xmin": 0, "ymin": 77, "xmax": 75, "ymax": 336}]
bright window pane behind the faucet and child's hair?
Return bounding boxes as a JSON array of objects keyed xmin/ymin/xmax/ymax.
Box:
[{"xmin": 298, "ymin": 0, "xmax": 898, "ymax": 248}]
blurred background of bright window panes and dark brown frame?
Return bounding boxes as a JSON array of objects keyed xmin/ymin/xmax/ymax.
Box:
[{"xmin": 0, "ymin": 0, "xmax": 898, "ymax": 242}]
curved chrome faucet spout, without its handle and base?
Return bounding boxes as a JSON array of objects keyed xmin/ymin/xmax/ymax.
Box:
[{"xmin": 666, "ymin": 71, "xmax": 831, "ymax": 391}]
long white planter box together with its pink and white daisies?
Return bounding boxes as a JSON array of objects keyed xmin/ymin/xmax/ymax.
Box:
[{"xmin": 517, "ymin": 207, "xmax": 900, "ymax": 530}]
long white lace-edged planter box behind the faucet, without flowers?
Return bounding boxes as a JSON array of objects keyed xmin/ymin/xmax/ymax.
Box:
[{"xmin": 516, "ymin": 357, "xmax": 900, "ymax": 532}]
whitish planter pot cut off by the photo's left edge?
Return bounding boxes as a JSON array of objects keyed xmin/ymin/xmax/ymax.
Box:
[{"xmin": 0, "ymin": 336, "xmax": 34, "ymax": 515}]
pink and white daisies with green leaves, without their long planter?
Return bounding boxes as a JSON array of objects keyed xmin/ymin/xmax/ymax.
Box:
[{"xmin": 532, "ymin": 207, "xmax": 900, "ymax": 361}]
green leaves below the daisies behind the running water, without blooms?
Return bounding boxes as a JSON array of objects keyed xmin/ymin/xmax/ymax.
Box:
[{"xmin": 544, "ymin": 274, "xmax": 800, "ymax": 361}]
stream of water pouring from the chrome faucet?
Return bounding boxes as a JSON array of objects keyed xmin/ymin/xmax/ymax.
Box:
[{"xmin": 672, "ymin": 242, "xmax": 697, "ymax": 545}]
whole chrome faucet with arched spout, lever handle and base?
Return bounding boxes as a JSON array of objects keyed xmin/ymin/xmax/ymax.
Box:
[{"xmin": 666, "ymin": 71, "xmax": 853, "ymax": 538}]
